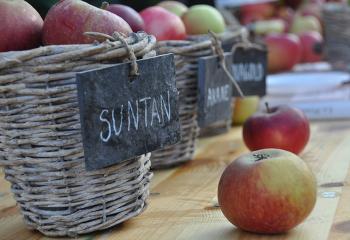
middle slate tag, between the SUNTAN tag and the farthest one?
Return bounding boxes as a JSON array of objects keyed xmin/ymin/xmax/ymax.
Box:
[{"xmin": 198, "ymin": 53, "xmax": 232, "ymax": 127}]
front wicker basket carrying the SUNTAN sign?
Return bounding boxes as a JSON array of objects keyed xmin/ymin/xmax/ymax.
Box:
[{"xmin": 0, "ymin": 33, "xmax": 156, "ymax": 236}]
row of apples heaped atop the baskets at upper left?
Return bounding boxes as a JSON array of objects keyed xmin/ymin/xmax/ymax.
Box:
[{"xmin": 0, "ymin": 0, "xmax": 230, "ymax": 52}]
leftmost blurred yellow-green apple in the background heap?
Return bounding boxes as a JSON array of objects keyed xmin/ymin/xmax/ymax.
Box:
[{"xmin": 250, "ymin": 19, "xmax": 286, "ymax": 35}]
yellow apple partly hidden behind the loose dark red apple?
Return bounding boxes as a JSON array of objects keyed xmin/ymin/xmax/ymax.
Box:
[{"xmin": 232, "ymin": 96, "xmax": 260, "ymax": 125}]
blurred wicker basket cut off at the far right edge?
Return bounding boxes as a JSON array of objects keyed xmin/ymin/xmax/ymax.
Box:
[{"xmin": 322, "ymin": 3, "xmax": 350, "ymax": 70}]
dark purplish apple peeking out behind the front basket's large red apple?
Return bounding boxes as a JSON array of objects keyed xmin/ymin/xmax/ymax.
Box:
[{"xmin": 102, "ymin": 2, "xmax": 145, "ymax": 32}]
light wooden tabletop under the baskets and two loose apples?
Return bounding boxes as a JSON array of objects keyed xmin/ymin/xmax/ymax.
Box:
[{"xmin": 0, "ymin": 121, "xmax": 350, "ymax": 240}]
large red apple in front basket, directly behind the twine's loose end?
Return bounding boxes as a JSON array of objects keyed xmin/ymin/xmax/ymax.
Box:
[{"xmin": 43, "ymin": 0, "xmax": 132, "ymax": 45}]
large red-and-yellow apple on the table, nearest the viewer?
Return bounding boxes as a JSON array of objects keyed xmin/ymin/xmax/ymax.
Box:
[{"xmin": 218, "ymin": 149, "xmax": 317, "ymax": 234}]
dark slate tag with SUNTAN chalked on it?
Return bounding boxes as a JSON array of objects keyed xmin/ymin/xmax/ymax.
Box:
[{"xmin": 77, "ymin": 54, "xmax": 181, "ymax": 170}]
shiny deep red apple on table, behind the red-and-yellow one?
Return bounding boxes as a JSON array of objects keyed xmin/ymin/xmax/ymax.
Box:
[{"xmin": 243, "ymin": 106, "xmax": 310, "ymax": 154}]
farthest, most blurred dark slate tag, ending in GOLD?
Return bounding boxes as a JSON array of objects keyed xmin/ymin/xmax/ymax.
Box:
[{"xmin": 232, "ymin": 47, "xmax": 267, "ymax": 96}]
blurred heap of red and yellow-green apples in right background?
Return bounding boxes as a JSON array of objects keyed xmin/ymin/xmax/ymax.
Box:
[{"xmin": 239, "ymin": 0, "xmax": 347, "ymax": 73}]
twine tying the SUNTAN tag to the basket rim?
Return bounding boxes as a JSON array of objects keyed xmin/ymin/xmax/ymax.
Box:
[{"xmin": 84, "ymin": 32, "xmax": 139, "ymax": 76}]
